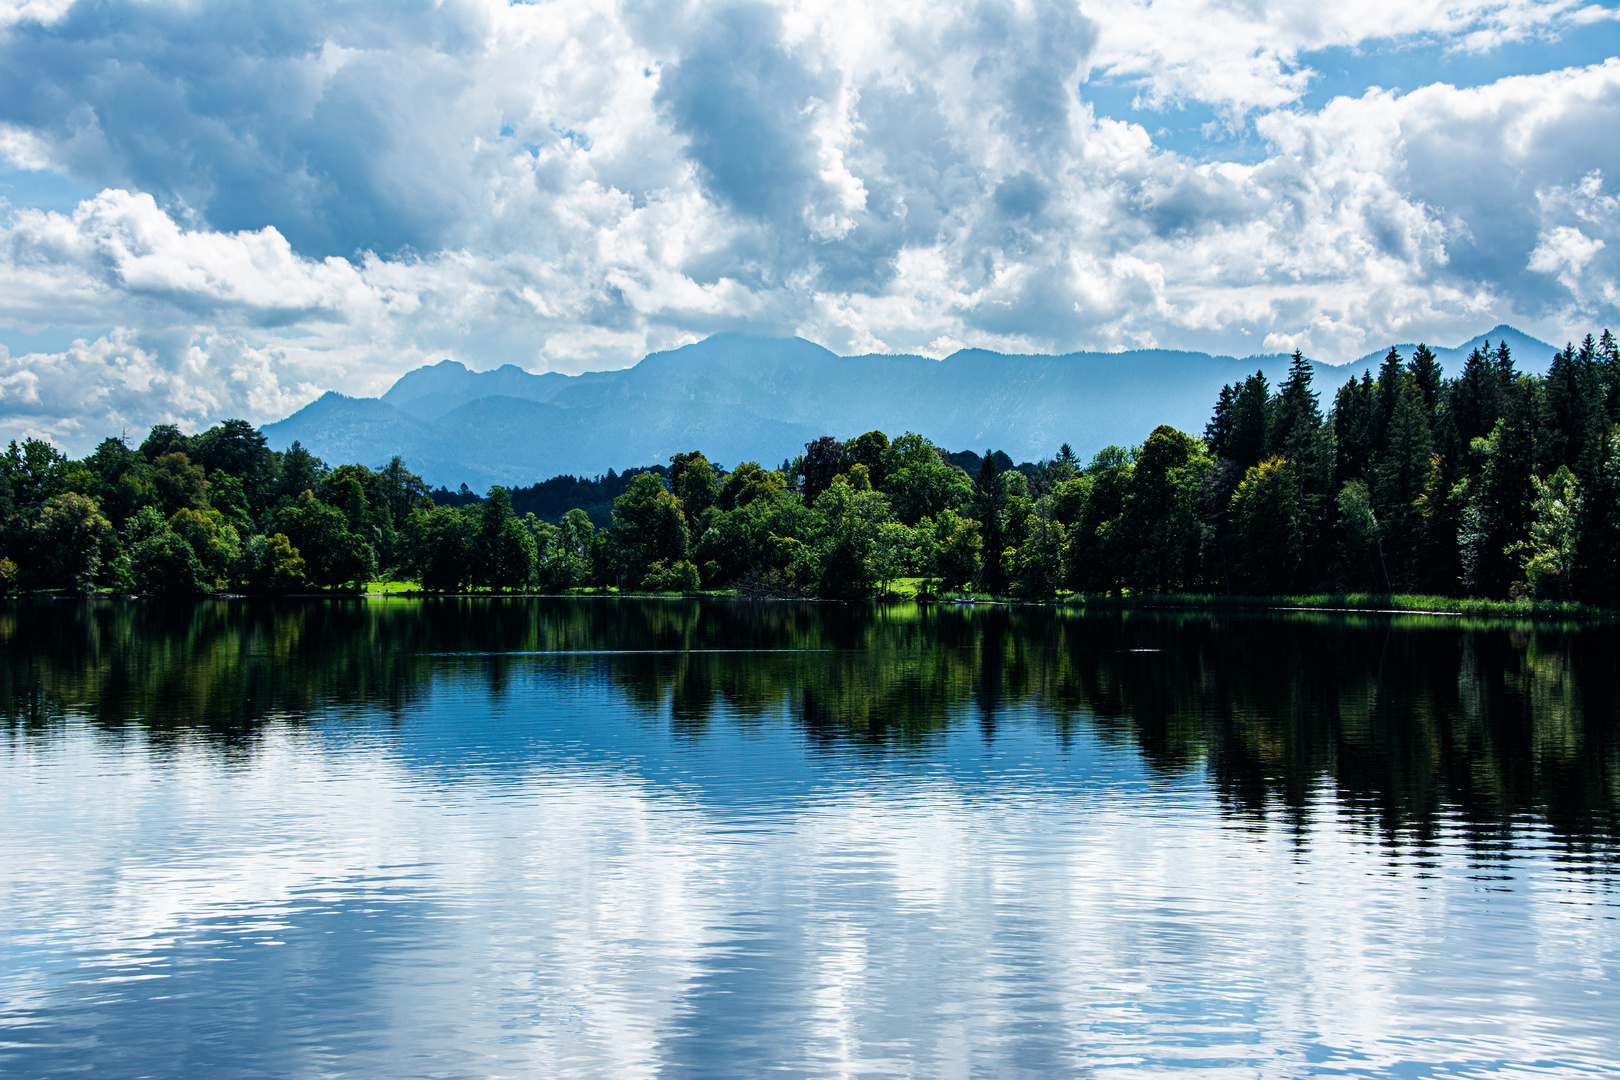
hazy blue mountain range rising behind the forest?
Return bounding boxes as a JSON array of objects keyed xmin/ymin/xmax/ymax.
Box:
[{"xmin": 264, "ymin": 325, "xmax": 1554, "ymax": 491}]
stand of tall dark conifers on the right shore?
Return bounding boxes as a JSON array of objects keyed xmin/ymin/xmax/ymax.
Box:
[{"xmin": 1205, "ymin": 330, "xmax": 1620, "ymax": 606}]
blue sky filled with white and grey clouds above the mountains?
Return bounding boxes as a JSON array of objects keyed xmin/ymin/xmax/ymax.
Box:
[{"xmin": 0, "ymin": 0, "xmax": 1620, "ymax": 452}]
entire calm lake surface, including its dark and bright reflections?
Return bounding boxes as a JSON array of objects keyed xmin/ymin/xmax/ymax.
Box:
[{"xmin": 0, "ymin": 599, "xmax": 1620, "ymax": 1077}]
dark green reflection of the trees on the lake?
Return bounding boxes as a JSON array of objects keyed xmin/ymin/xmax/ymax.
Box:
[{"xmin": 0, "ymin": 597, "xmax": 1620, "ymax": 852}]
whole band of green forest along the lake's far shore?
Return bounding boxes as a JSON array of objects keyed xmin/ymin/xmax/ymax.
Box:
[{"xmin": 0, "ymin": 330, "xmax": 1620, "ymax": 606}]
